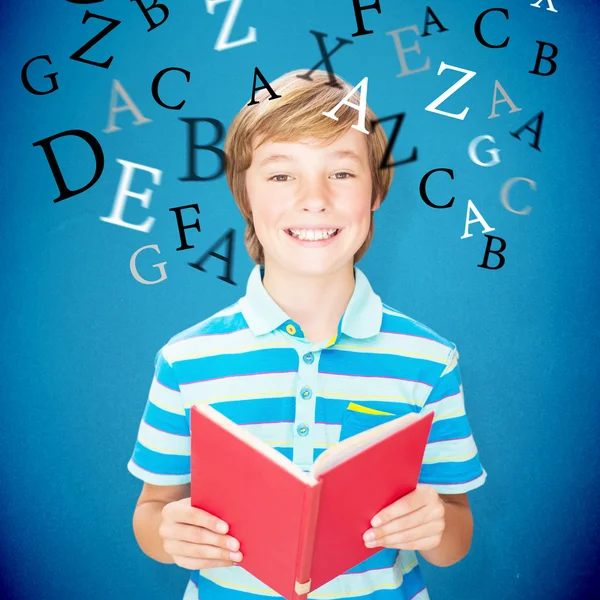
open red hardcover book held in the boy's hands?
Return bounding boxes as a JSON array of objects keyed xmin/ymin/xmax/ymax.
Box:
[{"xmin": 191, "ymin": 405, "xmax": 434, "ymax": 600}]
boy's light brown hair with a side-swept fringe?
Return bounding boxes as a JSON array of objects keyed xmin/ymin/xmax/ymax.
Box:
[{"xmin": 224, "ymin": 70, "xmax": 393, "ymax": 264}]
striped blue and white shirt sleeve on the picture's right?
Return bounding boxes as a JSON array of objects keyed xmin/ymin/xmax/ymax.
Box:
[{"xmin": 419, "ymin": 346, "xmax": 487, "ymax": 494}]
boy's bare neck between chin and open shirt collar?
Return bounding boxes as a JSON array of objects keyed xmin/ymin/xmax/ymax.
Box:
[{"xmin": 262, "ymin": 262, "xmax": 355, "ymax": 343}]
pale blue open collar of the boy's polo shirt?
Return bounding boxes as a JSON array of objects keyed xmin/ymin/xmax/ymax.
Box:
[{"xmin": 240, "ymin": 265, "xmax": 382, "ymax": 345}]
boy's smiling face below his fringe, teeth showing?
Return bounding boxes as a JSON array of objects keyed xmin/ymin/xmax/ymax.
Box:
[{"xmin": 246, "ymin": 129, "xmax": 380, "ymax": 275}]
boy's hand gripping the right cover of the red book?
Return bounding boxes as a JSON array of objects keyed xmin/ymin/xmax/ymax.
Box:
[{"xmin": 363, "ymin": 483, "xmax": 446, "ymax": 550}]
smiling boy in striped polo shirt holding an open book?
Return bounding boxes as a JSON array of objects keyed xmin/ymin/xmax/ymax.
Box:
[{"xmin": 128, "ymin": 71, "xmax": 486, "ymax": 600}]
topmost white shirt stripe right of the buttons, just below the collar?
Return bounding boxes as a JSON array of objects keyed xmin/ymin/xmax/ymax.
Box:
[{"xmin": 335, "ymin": 333, "xmax": 450, "ymax": 365}]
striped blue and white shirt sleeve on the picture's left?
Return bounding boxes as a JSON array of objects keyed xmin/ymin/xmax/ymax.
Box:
[{"xmin": 127, "ymin": 347, "xmax": 191, "ymax": 485}]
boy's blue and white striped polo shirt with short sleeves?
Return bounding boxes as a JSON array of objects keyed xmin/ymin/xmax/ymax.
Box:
[{"xmin": 128, "ymin": 265, "xmax": 487, "ymax": 600}]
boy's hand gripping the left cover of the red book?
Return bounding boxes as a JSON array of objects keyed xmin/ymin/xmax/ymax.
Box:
[{"xmin": 158, "ymin": 498, "xmax": 242, "ymax": 571}]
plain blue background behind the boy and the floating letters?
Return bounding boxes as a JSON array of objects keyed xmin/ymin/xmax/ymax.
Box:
[{"xmin": 0, "ymin": 0, "xmax": 600, "ymax": 600}]
